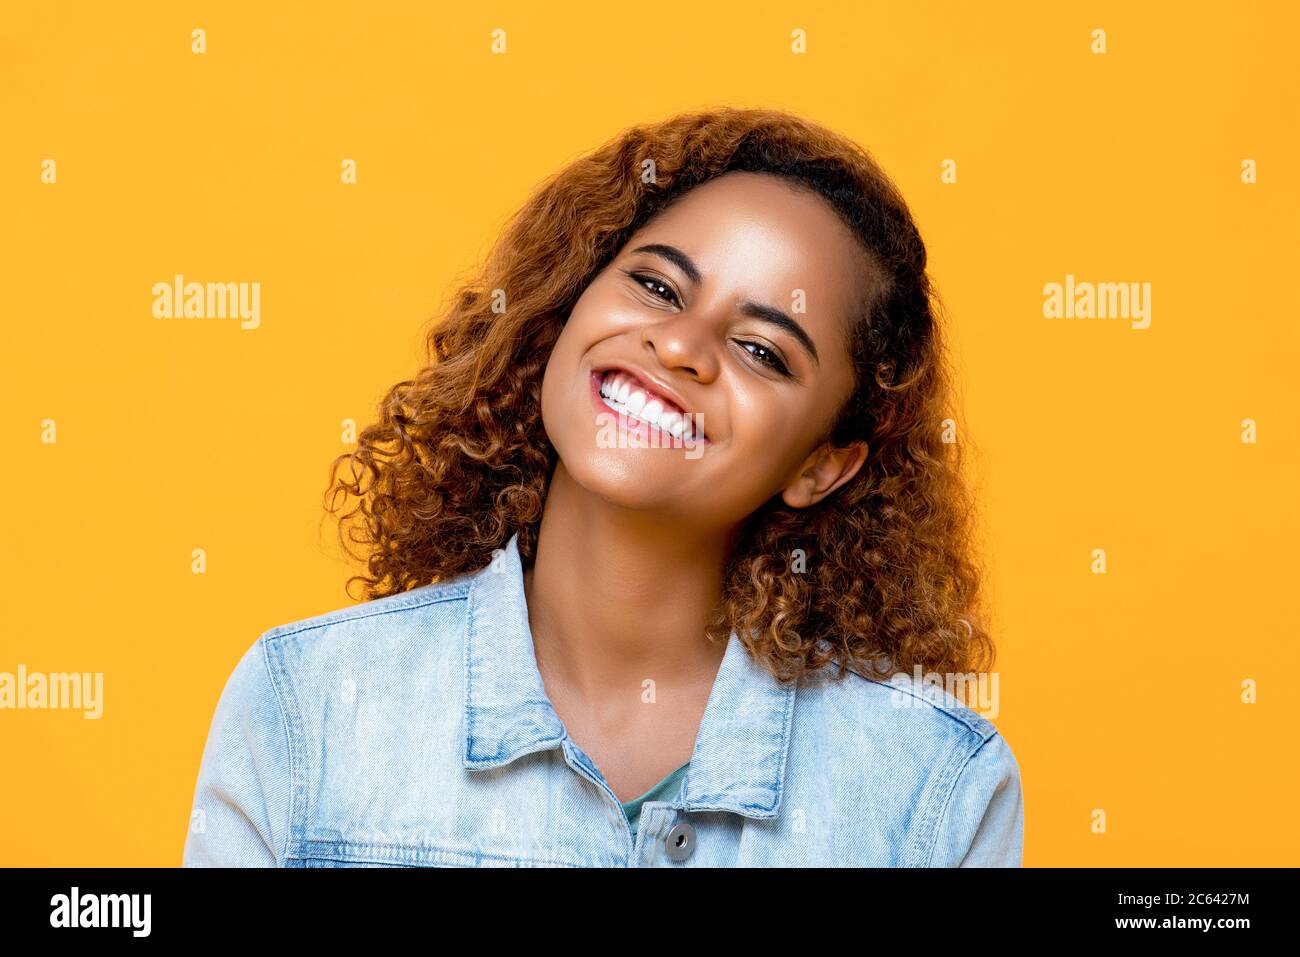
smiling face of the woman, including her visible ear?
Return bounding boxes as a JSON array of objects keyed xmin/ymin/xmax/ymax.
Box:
[{"xmin": 542, "ymin": 172, "xmax": 868, "ymax": 528}]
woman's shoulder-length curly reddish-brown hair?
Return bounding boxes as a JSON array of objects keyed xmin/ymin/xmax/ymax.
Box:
[{"xmin": 325, "ymin": 108, "xmax": 993, "ymax": 681}]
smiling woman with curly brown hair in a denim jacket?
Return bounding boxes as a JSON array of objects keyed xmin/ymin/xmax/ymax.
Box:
[{"xmin": 185, "ymin": 109, "xmax": 1023, "ymax": 866}]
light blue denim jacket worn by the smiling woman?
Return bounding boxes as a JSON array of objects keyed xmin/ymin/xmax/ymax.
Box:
[{"xmin": 183, "ymin": 536, "xmax": 1023, "ymax": 867}]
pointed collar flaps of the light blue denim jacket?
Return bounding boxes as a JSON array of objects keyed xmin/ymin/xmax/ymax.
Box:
[{"xmin": 464, "ymin": 532, "xmax": 796, "ymax": 818}]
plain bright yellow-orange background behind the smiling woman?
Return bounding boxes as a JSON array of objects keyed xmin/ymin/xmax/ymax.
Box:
[{"xmin": 0, "ymin": 0, "xmax": 1300, "ymax": 866}]
